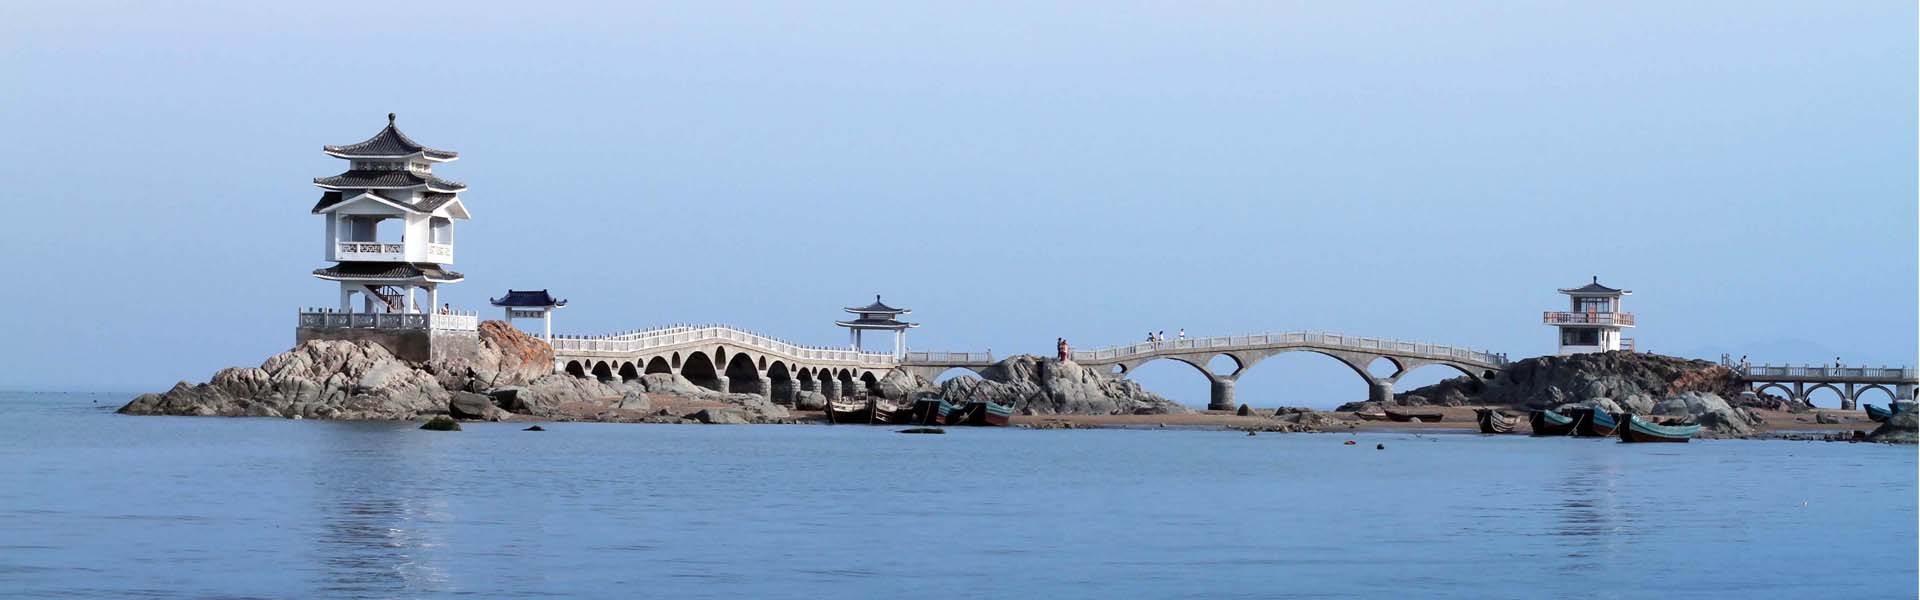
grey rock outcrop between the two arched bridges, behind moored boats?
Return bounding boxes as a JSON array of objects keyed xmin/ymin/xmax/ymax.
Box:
[{"xmin": 925, "ymin": 356, "xmax": 1192, "ymax": 415}]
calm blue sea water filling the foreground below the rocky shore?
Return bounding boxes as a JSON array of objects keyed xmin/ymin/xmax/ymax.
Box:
[{"xmin": 0, "ymin": 394, "xmax": 1916, "ymax": 598}]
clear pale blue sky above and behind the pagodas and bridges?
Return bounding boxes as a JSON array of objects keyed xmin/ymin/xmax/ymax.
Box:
[{"xmin": 0, "ymin": 2, "xmax": 1920, "ymax": 408}]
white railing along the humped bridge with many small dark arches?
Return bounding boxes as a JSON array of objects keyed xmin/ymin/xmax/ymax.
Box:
[{"xmin": 553, "ymin": 325, "xmax": 900, "ymax": 367}]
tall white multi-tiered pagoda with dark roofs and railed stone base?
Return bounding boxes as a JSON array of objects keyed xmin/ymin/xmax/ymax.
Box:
[{"xmin": 294, "ymin": 113, "xmax": 476, "ymax": 360}]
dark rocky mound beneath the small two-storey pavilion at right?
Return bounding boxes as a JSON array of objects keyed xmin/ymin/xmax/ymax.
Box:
[{"xmin": 1382, "ymin": 352, "xmax": 1766, "ymax": 437}]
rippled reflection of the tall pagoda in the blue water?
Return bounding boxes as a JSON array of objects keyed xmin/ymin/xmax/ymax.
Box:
[{"xmin": 309, "ymin": 423, "xmax": 447, "ymax": 596}]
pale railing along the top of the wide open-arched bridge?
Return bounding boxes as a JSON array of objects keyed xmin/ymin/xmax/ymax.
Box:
[{"xmin": 1073, "ymin": 331, "xmax": 1507, "ymax": 365}]
